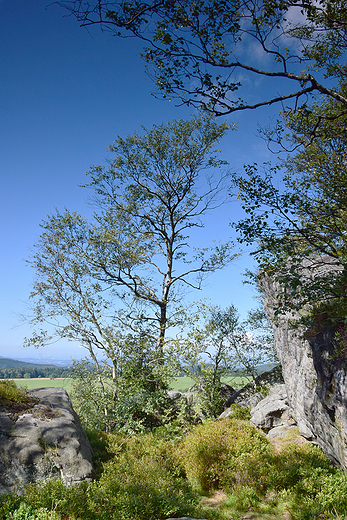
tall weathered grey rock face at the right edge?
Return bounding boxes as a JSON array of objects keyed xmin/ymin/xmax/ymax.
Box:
[{"xmin": 262, "ymin": 270, "xmax": 347, "ymax": 470}]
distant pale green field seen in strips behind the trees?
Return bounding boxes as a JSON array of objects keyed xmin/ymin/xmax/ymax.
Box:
[{"xmin": 8, "ymin": 376, "xmax": 249, "ymax": 392}]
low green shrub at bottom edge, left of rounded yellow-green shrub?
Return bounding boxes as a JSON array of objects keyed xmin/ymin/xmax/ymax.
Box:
[{"xmin": 88, "ymin": 452, "xmax": 198, "ymax": 520}]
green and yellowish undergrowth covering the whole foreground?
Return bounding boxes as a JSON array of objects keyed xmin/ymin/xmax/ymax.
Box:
[{"xmin": 0, "ymin": 407, "xmax": 347, "ymax": 520}]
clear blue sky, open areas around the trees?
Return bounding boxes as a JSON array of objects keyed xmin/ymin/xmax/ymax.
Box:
[{"xmin": 0, "ymin": 0, "xmax": 277, "ymax": 359}]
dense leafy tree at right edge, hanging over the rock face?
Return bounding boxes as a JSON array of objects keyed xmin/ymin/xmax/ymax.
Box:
[{"xmin": 234, "ymin": 89, "xmax": 347, "ymax": 324}]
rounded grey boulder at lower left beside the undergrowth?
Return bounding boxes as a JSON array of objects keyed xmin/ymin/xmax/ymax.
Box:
[{"xmin": 0, "ymin": 388, "xmax": 93, "ymax": 494}]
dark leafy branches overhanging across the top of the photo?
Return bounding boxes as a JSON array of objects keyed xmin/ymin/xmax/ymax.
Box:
[{"xmin": 55, "ymin": 0, "xmax": 347, "ymax": 119}]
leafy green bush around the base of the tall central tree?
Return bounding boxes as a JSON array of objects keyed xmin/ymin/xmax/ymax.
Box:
[{"xmin": 70, "ymin": 358, "xmax": 172, "ymax": 435}]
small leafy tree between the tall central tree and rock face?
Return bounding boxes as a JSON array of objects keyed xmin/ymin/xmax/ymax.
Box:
[{"xmin": 186, "ymin": 305, "xmax": 274, "ymax": 417}]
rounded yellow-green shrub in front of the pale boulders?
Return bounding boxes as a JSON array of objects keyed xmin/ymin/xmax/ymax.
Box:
[{"xmin": 182, "ymin": 420, "xmax": 272, "ymax": 493}]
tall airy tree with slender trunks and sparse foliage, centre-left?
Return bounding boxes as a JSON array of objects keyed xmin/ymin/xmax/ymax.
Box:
[{"xmin": 27, "ymin": 116, "xmax": 235, "ymax": 430}]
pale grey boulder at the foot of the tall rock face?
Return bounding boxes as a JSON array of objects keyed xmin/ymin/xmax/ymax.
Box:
[{"xmin": 251, "ymin": 385, "xmax": 293, "ymax": 432}]
